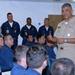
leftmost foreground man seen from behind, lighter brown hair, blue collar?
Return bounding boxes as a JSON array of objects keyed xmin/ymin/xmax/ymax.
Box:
[{"xmin": 11, "ymin": 45, "xmax": 29, "ymax": 75}]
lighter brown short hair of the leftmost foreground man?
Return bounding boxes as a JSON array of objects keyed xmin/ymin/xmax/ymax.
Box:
[{"xmin": 15, "ymin": 45, "xmax": 29, "ymax": 62}]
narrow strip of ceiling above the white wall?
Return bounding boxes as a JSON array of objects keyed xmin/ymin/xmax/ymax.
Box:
[{"xmin": 0, "ymin": 0, "xmax": 75, "ymax": 3}]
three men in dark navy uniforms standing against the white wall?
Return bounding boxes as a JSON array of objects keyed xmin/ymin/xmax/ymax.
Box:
[{"xmin": 1, "ymin": 13, "xmax": 54, "ymax": 48}]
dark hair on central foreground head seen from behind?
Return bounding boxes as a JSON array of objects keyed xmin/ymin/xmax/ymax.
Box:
[{"xmin": 26, "ymin": 44, "xmax": 47, "ymax": 68}]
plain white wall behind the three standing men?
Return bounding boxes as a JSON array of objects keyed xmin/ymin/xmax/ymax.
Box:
[{"xmin": 0, "ymin": 1, "xmax": 75, "ymax": 44}]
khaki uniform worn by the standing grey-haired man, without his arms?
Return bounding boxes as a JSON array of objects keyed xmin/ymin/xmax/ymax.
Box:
[{"xmin": 54, "ymin": 17, "xmax": 75, "ymax": 63}]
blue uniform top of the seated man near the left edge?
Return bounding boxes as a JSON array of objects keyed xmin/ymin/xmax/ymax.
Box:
[{"xmin": 1, "ymin": 50, "xmax": 14, "ymax": 70}]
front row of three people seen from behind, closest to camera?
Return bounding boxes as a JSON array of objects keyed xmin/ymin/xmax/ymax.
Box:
[{"xmin": 0, "ymin": 39, "xmax": 75, "ymax": 75}]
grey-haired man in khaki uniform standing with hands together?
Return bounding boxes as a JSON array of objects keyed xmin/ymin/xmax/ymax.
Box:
[{"xmin": 50, "ymin": 3, "xmax": 75, "ymax": 63}]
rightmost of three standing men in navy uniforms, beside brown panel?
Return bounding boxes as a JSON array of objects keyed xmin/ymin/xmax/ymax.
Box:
[{"xmin": 38, "ymin": 18, "xmax": 54, "ymax": 37}]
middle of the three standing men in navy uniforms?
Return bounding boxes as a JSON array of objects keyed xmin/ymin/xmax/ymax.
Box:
[{"xmin": 20, "ymin": 17, "xmax": 37, "ymax": 45}]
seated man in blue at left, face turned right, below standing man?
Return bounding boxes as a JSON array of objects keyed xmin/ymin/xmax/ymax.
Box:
[{"xmin": 0, "ymin": 34, "xmax": 14, "ymax": 71}]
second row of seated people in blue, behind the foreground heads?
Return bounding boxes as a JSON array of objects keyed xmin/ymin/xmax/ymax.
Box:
[{"xmin": 0, "ymin": 34, "xmax": 56, "ymax": 75}]
